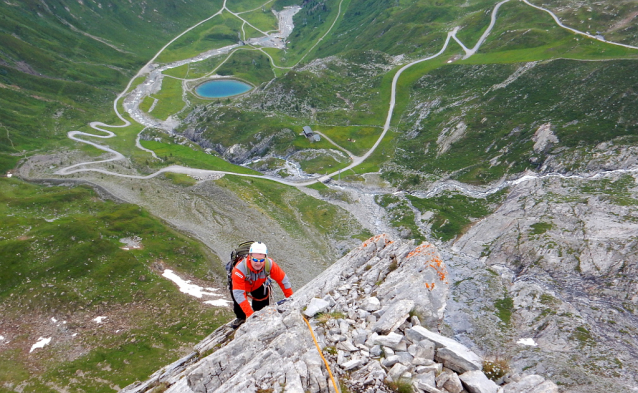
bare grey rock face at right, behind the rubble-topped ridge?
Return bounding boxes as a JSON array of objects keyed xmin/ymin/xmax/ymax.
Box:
[{"xmin": 452, "ymin": 171, "xmax": 638, "ymax": 393}]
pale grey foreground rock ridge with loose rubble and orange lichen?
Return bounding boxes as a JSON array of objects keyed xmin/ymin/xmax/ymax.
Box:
[{"xmin": 123, "ymin": 235, "xmax": 555, "ymax": 393}]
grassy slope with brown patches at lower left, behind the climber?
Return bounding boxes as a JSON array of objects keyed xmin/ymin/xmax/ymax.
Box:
[{"xmin": 0, "ymin": 179, "xmax": 234, "ymax": 392}]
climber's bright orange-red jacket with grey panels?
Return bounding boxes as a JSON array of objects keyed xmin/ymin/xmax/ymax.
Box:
[{"xmin": 231, "ymin": 257, "xmax": 292, "ymax": 318}]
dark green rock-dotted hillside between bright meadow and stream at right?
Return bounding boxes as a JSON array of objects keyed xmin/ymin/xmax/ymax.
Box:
[{"xmin": 396, "ymin": 60, "xmax": 638, "ymax": 182}]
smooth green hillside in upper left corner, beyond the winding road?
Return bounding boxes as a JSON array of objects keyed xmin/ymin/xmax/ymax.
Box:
[{"xmin": 0, "ymin": 0, "xmax": 226, "ymax": 170}]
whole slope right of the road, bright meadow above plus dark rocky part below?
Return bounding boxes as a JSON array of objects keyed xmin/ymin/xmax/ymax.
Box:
[{"xmin": 396, "ymin": 0, "xmax": 638, "ymax": 182}]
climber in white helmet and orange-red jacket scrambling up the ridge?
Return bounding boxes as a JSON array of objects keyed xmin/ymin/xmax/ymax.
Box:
[{"xmin": 230, "ymin": 242, "xmax": 292, "ymax": 329}]
